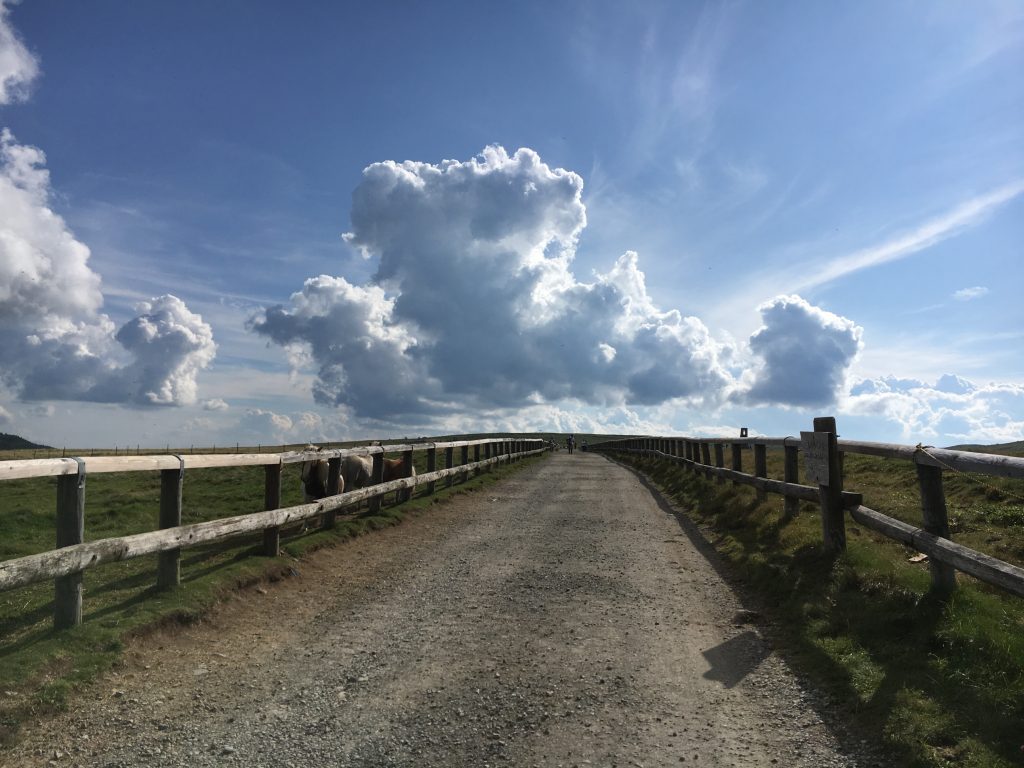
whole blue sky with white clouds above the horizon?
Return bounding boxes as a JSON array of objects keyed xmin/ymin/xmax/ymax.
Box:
[{"xmin": 0, "ymin": 0, "xmax": 1024, "ymax": 446}]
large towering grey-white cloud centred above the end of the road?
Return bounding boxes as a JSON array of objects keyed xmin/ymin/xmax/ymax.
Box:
[{"xmin": 252, "ymin": 146, "xmax": 730, "ymax": 418}]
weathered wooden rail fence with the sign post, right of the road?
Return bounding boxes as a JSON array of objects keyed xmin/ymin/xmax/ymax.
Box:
[{"xmin": 590, "ymin": 417, "xmax": 1024, "ymax": 597}]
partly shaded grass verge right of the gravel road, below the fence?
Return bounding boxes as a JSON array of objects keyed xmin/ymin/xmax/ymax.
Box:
[{"xmin": 626, "ymin": 459, "xmax": 1024, "ymax": 768}]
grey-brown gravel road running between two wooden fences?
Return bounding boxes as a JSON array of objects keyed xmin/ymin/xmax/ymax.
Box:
[{"xmin": 0, "ymin": 453, "xmax": 882, "ymax": 768}]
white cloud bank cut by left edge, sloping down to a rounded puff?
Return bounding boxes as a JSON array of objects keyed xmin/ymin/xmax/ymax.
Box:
[{"xmin": 0, "ymin": 130, "xmax": 216, "ymax": 406}]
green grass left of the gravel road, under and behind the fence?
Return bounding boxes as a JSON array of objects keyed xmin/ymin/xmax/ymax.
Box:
[{"xmin": 0, "ymin": 455, "xmax": 546, "ymax": 748}]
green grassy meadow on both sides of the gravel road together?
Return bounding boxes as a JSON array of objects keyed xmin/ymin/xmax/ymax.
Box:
[{"xmin": 0, "ymin": 434, "xmax": 1024, "ymax": 768}]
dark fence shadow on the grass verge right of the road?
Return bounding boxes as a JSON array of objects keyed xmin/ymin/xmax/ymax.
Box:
[{"xmin": 602, "ymin": 462, "xmax": 1024, "ymax": 764}]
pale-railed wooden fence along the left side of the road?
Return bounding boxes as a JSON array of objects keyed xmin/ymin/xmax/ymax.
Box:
[{"xmin": 0, "ymin": 437, "xmax": 551, "ymax": 629}]
